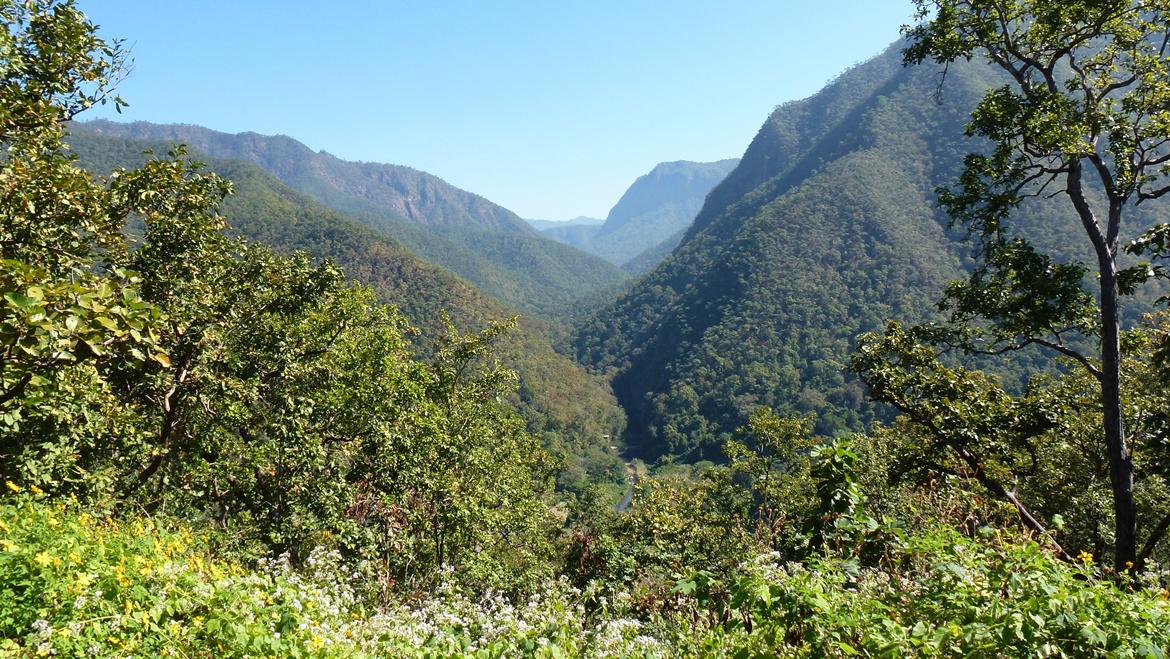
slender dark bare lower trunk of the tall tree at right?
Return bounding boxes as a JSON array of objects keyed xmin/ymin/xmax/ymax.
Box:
[{"xmin": 1100, "ymin": 266, "xmax": 1137, "ymax": 572}]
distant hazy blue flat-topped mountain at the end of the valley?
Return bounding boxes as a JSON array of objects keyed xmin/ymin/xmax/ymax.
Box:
[{"xmin": 538, "ymin": 159, "xmax": 738, "ymax": 272}]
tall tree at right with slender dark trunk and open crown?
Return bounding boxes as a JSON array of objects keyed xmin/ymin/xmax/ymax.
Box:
[{"xmin": 904, "ymin": 0, "xmax": 1170, "ymax": 571}]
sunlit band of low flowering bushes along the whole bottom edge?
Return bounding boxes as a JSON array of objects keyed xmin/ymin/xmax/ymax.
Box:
[{"xmin": 0, "ymin": 486, "xmax": 1170, "ymax": 658}]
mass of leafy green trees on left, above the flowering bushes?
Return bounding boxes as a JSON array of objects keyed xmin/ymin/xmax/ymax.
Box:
[{"xmin": 0, "ymin": 2, "xmax": 555, "ymax": 591}]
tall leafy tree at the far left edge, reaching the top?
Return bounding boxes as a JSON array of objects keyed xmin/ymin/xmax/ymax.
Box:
[{"xmin": 0, "ymin": 1, "xmax": 167, "ymax": 488}]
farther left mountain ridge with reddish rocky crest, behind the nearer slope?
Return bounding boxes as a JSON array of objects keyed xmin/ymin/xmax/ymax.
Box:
[{"xmin": 73, "ymin": 121, "xmax": 625, "ymax": 317}]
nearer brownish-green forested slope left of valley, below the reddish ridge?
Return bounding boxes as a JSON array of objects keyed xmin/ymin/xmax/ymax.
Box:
[{"xmin": 69, "ymin": 130, "xmax": 624, "ymax": 482}]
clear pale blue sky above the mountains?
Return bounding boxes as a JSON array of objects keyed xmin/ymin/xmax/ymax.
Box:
[{"xmin": 78, "ymin": 0, "xmax": 913, "ymax": 219}]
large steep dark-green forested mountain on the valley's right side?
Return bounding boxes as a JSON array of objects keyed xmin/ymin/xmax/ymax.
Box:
[{"xmin": 576, "ymin": 44, "xmax": 1170, "ymax": 459}]
